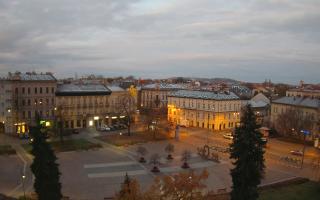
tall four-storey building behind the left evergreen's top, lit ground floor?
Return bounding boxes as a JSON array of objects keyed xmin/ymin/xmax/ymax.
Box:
[{"xmin": 8, "ymin": 72, "xmax": 57, "ymax": 136}]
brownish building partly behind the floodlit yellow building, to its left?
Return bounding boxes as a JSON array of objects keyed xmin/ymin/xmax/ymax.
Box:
[{"xmin": 141, "ymin": 83, "xmax": 186, "ymax": 109}]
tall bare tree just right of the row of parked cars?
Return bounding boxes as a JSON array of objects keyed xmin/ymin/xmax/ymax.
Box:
[{"xmin": 117, "ymin": 93, "xmax": 136, "ymax": 136}]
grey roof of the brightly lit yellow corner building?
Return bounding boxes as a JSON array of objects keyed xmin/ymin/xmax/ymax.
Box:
[{"xmin": 168, "ymin": 90, "xmax": 239, "ymax": 100}]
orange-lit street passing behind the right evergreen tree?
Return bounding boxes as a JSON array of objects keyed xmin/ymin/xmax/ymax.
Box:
[{"xmin": 181, "ymin": 128, "xmax": 320, "ymax": 180}]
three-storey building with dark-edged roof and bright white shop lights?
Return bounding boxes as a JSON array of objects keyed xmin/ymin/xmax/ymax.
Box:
[{"xmin": 56, "ymin": 83, "xmax": 111, "ymax": 129}]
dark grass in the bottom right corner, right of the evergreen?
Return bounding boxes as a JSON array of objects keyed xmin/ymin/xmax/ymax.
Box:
[{"xmin": 259, "ymin": 181, "xmax": 320, "ymax": 200}]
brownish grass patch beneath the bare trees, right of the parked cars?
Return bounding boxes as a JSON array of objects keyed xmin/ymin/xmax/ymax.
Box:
[{"xmin": 97, "ymin": 131, "xmax": 170, "ymax": 146}]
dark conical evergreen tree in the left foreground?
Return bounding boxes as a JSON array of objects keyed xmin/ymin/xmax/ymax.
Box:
[{"xmin": 30, "ymin": 121, "xmax": 62, "ymax": 200}]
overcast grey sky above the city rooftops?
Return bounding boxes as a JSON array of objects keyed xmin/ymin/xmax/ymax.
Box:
[{"xmin": 0, "ymin": 0, "xmax": 320, "ymax": 83}]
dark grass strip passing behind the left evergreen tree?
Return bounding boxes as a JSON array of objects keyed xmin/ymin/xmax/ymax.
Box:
[{"xmin": 22, "ymin": 139, "xmax": 102, "ymax": 152}]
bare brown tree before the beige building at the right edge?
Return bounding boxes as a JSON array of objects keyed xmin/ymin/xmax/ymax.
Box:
[{"xmin": 275, "ymin": 109, "xmax": 314, "ymax": 139}]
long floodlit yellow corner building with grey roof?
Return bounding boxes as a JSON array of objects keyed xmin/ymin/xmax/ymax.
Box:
[{"xmin": 168, "ymin": 90, "xmax": 241, "ymax": 130}]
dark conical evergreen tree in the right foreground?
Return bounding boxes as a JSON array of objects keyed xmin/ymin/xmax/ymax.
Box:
[{"xmin": 230, "ymin": 105, "xmax": 265, "ymax": 200}]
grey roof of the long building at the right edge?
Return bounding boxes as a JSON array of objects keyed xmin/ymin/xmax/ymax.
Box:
[{"xmin": 272, "ymin": 97, "xmax": 320, "ymax": 108}]
